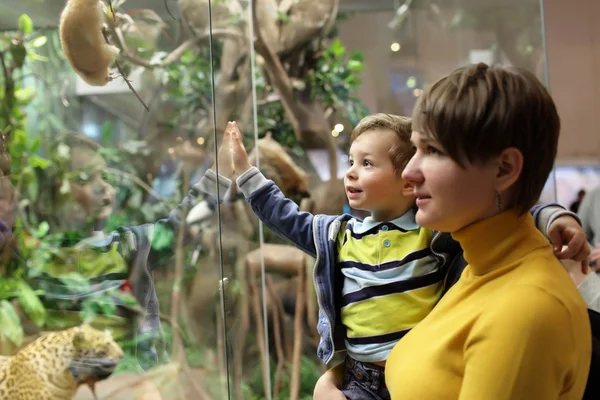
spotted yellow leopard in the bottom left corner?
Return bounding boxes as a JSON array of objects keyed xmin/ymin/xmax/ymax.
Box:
[{"xmin": 0, "ymin": 325, "xmax": 123, "ymax": 400}]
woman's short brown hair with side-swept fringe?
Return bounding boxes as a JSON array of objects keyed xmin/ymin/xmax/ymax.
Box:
[{"xmin": 413, "ymin": 63, "xmax": 560, "ymax": 213}]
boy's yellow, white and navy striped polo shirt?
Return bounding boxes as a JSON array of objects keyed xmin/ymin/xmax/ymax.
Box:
[{"xmin": 337, "ymin": 210, "xmax": 444, "ymax": 362}]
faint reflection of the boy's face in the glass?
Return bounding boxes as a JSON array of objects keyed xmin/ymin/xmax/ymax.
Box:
[{"xmin": 71, "ymin": 148, "xmax": 115, "ymax": 222}]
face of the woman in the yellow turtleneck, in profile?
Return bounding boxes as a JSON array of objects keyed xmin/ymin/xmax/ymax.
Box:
[{"xmin": 402, "ymin": 132, "xmax": 498, "ymax": 232}]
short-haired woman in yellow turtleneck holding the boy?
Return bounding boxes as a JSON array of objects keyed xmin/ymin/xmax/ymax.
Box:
[{"xmin": 386, "ymin": 64, "xmax": 591, "ymax": 400}]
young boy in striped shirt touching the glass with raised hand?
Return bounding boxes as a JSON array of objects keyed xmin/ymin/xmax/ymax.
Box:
[{"xmin": 200, "ymin": 114, "xmax": 584, "ymax": 399}]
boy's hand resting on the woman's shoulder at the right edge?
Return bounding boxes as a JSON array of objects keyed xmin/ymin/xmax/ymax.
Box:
[{"xmin": 548, "ymin": 215, "xmax": 590, "ymax": 273}]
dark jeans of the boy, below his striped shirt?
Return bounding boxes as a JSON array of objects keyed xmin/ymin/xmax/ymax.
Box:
[{"xmin": 342, "ymin": 357, "xmax": 390, "ymax": 400}]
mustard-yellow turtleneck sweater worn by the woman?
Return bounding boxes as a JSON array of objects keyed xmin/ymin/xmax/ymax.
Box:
[{"xmin": 385, "ymin": 211, "xmax": 591, "ymax": 400}]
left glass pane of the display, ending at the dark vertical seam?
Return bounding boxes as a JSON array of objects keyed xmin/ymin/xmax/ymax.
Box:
[{"xmin": 0, "ymin": 0, "xmax": 233, "ymax": 399}]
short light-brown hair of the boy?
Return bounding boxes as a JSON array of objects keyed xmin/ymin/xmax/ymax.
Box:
[{"xmin": 350, "ymin": 113, "xmax": 415, "ymax": 173}]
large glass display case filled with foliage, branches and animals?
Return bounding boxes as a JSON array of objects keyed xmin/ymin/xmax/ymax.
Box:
[{"xmin": 0, "ymin": 0, "xmax": 576, "ymax": 399}]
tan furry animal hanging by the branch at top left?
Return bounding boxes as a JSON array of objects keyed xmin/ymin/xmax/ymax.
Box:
[{"xmin": 59, "ymin": 0, "xmax": 119, "ymax": 86}]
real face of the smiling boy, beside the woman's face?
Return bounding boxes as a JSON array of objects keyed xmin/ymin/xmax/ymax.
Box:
[{"xmin": 344, "ymin": 129, "xmax": 414, "ymax": 221}]
